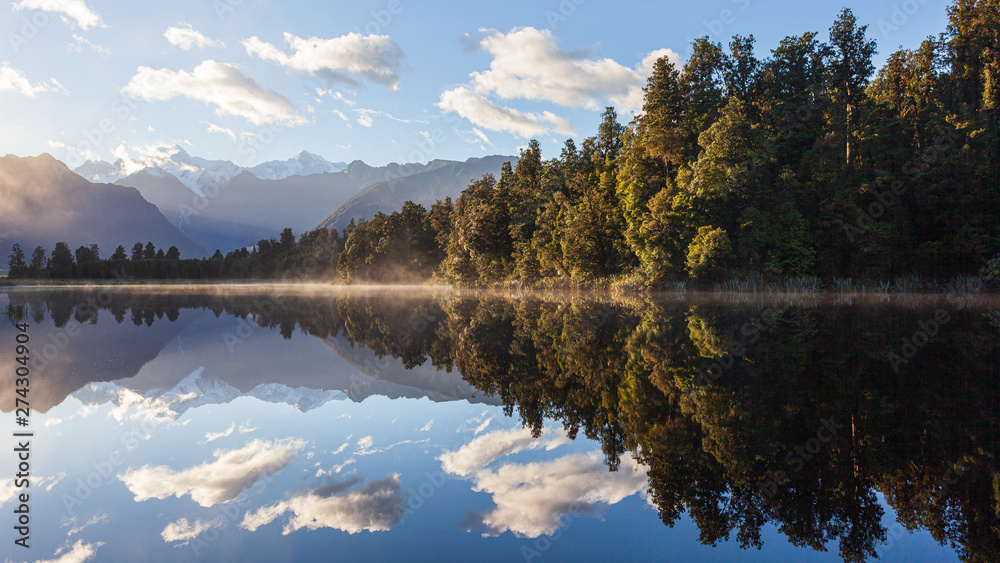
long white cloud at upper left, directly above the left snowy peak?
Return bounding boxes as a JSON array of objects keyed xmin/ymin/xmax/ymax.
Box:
[{"xmin": 122, "ymin": 60, "xmax": 305, "ymax": 125}]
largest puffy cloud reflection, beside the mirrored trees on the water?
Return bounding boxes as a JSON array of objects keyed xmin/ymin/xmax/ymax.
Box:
[{"xmin": 473, "ymin": 452, "xmax": 647, "ymax": 538}]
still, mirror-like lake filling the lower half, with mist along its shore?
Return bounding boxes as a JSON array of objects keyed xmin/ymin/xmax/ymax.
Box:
[{"xmin": 0, "ymin": 286, "xmax": 1000, "ymax": 562}]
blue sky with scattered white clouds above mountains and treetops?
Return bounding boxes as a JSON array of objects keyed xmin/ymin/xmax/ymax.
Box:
[{"xmin": 0, "ymin": 0, "xmax": 949, "ymax": 166}]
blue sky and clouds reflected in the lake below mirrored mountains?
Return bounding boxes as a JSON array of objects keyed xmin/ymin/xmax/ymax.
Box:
[{"xmin": 0, "ymin": 302, "xmax": 968, "ymax": 561}]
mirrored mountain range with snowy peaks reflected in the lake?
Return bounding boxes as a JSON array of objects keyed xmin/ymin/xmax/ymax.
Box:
[{"xmin": 0, "ymin": 290, "xmax": 499, "ymax": 413}]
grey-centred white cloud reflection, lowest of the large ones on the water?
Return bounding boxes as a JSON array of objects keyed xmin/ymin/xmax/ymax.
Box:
[{"xmin": 240, "ymin": 473, "xmax": 408, "ymax": 535}]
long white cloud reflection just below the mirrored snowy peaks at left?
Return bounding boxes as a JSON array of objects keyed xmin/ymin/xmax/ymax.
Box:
[{"xmin": 118, "ymin": 439, "xmax": 305, "ymax": 506}]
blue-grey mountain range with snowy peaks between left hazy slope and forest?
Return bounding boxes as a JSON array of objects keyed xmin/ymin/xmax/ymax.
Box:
[{"xmin": 68, "ymin": 146, "xmax": 516, "ymax": 256}]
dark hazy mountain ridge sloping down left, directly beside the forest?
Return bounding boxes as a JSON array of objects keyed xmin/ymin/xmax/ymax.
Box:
[{"xmin": 318, "ymin": 156, "xmax": 517, "ymax": 230}]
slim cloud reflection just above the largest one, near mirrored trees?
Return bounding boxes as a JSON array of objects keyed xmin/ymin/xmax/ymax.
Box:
[{"xmin": 438, "ymin": 428, "xmax": 569, "ymax": 477}]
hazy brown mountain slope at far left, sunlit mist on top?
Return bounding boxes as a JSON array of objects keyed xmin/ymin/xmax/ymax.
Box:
[{"xmin": 0, "ymin": 154, "xmax": 205, "ymax": 258}]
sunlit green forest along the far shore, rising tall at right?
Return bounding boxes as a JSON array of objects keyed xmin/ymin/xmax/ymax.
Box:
[{"xmin": 9, "ymin": 0, "xmax": 1000, "ymax": 288}]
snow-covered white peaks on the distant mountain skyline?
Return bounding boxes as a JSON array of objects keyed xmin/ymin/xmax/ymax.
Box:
[{"xmin": 74, "ymin": 145, "xmax": 347, "ymax": 194}]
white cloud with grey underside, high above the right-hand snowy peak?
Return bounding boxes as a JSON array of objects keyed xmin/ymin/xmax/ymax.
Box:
[{"xmin": 243, "ymin": 33, "xmax": 404, "ymax": 90}]
